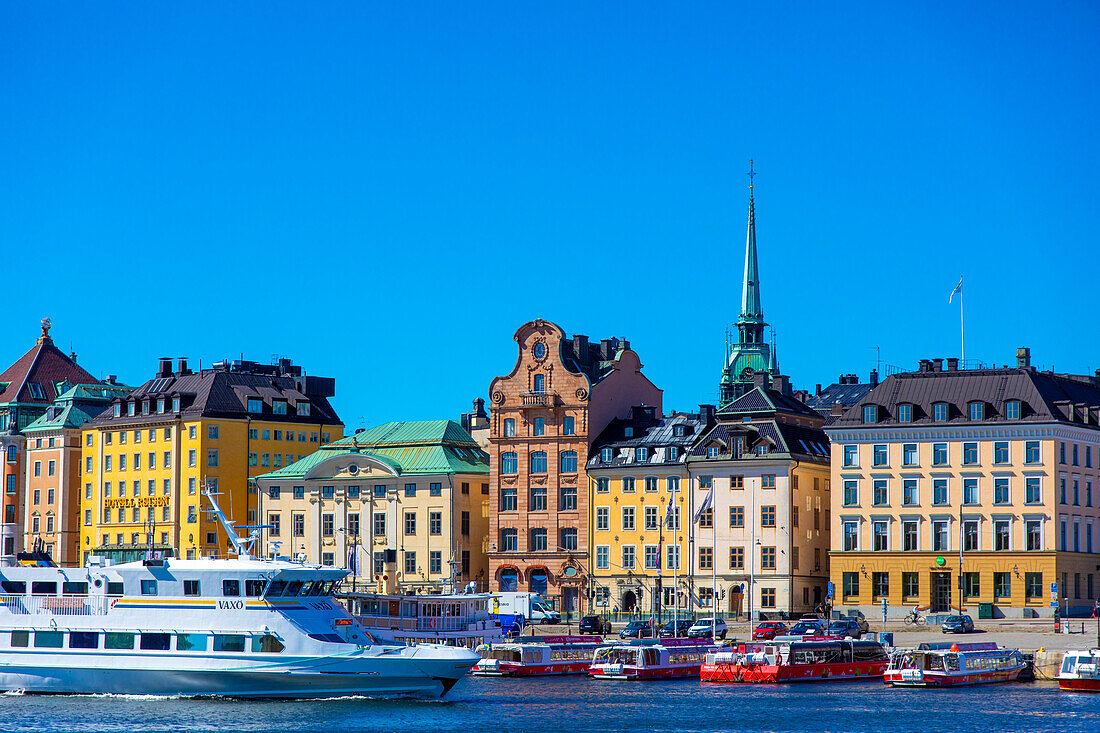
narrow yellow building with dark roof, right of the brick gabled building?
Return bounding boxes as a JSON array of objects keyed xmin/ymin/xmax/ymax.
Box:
[{"xmin": 586, "ymin": 406, "xmax": 713, "ymax": 616}]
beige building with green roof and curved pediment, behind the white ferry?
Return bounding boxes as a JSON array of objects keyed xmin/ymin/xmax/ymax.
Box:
[{"xmin": 256, "ymin": 420, "xmax": 488, "ymax": 592}]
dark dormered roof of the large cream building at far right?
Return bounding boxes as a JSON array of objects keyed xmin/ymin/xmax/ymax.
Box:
[{"xmin": 831, "ymin": 368, "xmax": 1100, "ymax": 428}]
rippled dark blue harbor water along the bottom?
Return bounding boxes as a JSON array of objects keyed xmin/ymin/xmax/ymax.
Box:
[{"xmin": 0, "ymin": 677, "xmax": 1100, "ymax": 733}]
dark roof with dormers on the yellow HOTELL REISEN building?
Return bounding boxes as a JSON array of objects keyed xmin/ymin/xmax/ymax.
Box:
[{"xmin": 92, "ymin": 369, "xmax": 342, "ymax": 426}]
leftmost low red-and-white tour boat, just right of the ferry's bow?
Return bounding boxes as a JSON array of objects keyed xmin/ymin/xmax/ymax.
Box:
[{"xmin": 472, "ymin": 636, "xmax": 604, "ymax": 677}]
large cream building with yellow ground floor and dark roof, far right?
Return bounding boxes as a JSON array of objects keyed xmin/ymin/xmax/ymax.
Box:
[{"xmin": 826, "ymin": 349, "xmax": 1100, "ymax": 617}]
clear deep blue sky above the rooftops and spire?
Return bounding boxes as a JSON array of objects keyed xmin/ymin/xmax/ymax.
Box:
[{"xmin": 0, "ymin": 2, "xmax": 1100, "ymax": 427}]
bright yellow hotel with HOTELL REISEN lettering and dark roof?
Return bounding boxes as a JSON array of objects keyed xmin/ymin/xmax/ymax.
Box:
[{"xmin": 80, "ymin": 359, "xmax": 343, "ymax": 560}]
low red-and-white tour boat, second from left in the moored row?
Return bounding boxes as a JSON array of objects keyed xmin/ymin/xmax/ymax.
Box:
[{"xmin": 589, "ymin": 638, "xmax": 718, "ymax": 680}]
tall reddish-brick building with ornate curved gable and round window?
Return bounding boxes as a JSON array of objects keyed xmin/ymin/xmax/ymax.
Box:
[{"xmin": 488, "ymin": 319, "xmax": 661, "ymax": 612}]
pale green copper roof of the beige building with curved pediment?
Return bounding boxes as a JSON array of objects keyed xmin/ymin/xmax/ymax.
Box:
[{"xmin": 261, "ymin": 420, "xmax": 488, "ymax": 481}]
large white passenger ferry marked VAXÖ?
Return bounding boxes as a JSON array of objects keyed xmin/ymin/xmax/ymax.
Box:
[{"xmin": 0, "ymin": 494, "xmax": 477, "ymax": 698}]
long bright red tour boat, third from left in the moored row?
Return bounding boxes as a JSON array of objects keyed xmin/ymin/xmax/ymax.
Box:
[{"xmin": 700, "ymin": 638, "xmax": 890, "ymax": 682}]
